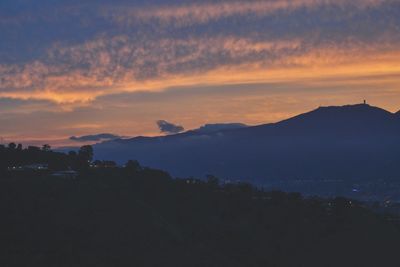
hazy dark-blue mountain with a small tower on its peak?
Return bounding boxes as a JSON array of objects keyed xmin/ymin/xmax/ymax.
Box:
[{"xmin": 94, "ymin": 104, "xmax": 400, "ymax": 189}]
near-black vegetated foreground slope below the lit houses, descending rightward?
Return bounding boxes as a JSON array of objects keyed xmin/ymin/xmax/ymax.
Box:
[{"xmin": 0, "ymin": 146, "xmax": 400, "ymax": 267}]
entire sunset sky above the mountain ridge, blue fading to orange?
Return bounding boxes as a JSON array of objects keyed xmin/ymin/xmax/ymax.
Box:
[{"xmin": 0, "ymin": 0, "xmax": 400, "ymax": 146}]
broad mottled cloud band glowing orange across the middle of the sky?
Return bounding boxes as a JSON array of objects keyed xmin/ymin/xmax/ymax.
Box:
[{"xmin": 0, "ymin": 36, "xmax": 400, "ymax": 104}]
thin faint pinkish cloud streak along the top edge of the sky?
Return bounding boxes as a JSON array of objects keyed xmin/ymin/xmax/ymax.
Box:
[{"xmin": 102, "ymin": 0, "xmax": 388, "ymax": 26}]
